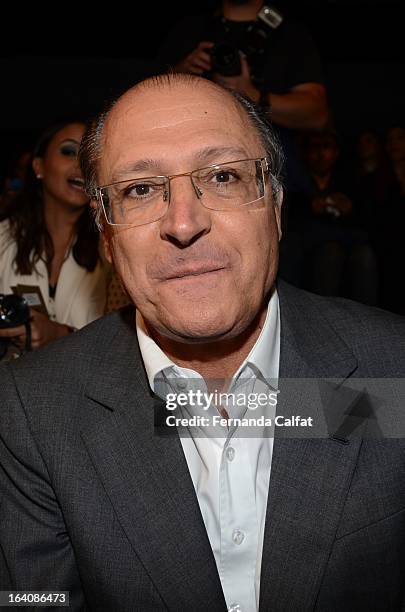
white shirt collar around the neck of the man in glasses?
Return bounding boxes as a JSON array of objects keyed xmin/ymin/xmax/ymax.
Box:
[{"xmin": 136, "ymin": 289, "xmax": 280, "ymax": 390}]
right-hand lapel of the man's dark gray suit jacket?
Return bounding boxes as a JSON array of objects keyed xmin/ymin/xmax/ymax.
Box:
[{"xmin": 260, "ymin": 284, "xmax": 361, "ymax": 612}]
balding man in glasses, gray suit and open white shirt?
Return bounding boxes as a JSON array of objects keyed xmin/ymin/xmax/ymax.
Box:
[{"xmin": 0, "ymin": 75, "xmax": 405, "ymax": 612}]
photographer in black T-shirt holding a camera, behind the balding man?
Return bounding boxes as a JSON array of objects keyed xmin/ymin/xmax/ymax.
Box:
[{"xmin": 159, "ymin": 0, "xmax": 328, "ymax": 130}]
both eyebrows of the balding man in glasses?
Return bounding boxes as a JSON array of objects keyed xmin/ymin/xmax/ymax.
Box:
[{"xmin": 109, "ymin": 147, "xmax": 249, "ymax": 183}]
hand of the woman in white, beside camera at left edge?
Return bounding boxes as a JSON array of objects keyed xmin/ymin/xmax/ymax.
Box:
[{"xmin": 0, "ymin": 309, "xmax": 71, "ymax": 349}]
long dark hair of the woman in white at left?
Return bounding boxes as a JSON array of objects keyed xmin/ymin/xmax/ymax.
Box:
[{"xmin": 6, "ymin": 119, "xmax": 99, "ymax": 274}]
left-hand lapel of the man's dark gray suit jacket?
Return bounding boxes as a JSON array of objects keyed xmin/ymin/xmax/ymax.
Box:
[{"xmin": 81, "ymin": 311, "xmax": 226, "ymax": 611}]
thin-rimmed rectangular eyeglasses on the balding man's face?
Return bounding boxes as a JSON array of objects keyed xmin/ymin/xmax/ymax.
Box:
[{"xmin": 93, "ymin": 157, "xmax": 269, "ymax": 227}]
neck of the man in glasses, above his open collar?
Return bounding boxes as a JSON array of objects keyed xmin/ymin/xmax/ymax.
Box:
[{"xmin": 145, "ymin": 303, "xmax": 268, "ymax": 381}]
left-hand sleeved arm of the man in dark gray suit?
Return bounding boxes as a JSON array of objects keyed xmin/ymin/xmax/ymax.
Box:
[{"xmin": 0, "ymin": 366, "xmax": 85, "ymax": 610}]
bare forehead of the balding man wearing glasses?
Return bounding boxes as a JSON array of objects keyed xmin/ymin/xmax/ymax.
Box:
[{"xmin": 99, "ymin": 82, "xmax": 261, "ymax": 177}]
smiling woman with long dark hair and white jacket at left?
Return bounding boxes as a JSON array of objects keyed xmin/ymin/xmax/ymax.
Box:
[{"xmin": 0, "ymin": 121, "xmax": 106, "ymax": 348}]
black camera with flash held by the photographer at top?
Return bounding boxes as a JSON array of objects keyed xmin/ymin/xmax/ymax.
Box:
[{"xmin": 210, "ymin": 6, "xmax": 283, "ymax": 87}]
